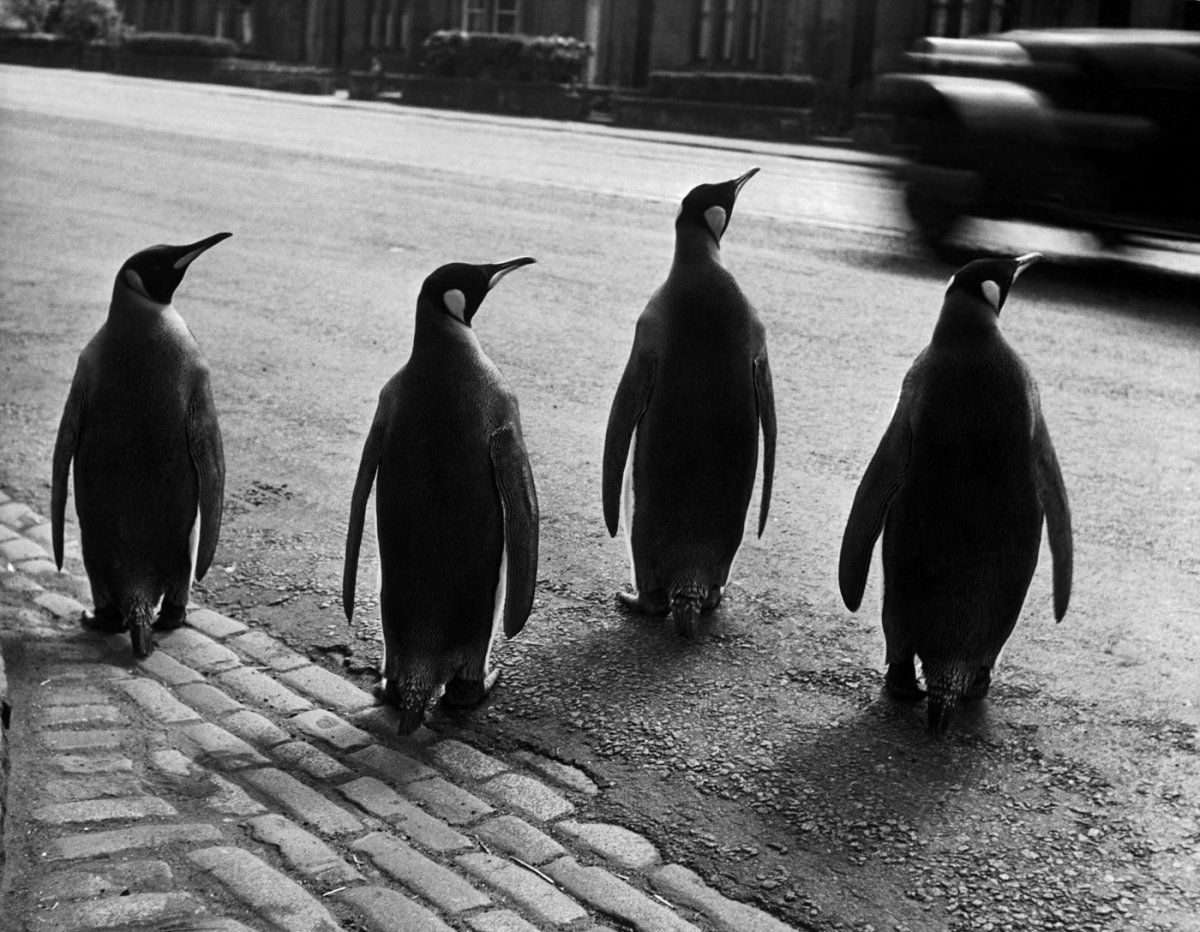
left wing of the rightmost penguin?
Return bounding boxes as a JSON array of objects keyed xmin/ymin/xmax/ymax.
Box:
[{"xmin": 838, "ymin": 393, "xmax": 911, "ymax": 612}]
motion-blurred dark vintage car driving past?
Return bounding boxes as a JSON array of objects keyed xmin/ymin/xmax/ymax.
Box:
[{"xmin": 874, "ymin": 29, "xmax": 1200, "ymax": 247}]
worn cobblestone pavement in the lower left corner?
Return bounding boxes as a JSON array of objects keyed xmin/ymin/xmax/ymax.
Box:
[{"xmin": 0, "ymin": 492, "xmax": 787, "ymax": 932}]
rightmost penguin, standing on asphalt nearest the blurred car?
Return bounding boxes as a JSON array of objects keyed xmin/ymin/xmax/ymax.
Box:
[{"xmin": 838, "ymin": 252, "xmax": 1073, "ymax": 734}]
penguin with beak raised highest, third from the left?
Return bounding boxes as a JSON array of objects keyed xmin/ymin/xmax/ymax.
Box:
[{"xmin": 602, "ymin": 168, "xmax": 775, "ymax": 638}]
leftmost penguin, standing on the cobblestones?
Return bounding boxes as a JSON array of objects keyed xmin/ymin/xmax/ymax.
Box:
[{"xmin": 50, "ymin": 233, "xmax": 233, "ymax": 657}]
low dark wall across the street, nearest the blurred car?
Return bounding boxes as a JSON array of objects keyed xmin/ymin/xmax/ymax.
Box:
[{"xmin": 612, "ymin": 94, "xmax": 814, "ymax": 143}]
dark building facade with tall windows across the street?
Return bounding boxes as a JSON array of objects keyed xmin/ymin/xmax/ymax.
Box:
[{"xmin": 110, "ymin": 0, "xmax": 1200, "ymax": 91}]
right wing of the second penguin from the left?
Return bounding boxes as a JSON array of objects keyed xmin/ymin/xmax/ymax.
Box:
[{"xmin": 488, "ymin": 421, "xmax": 538, "ymax": 637}]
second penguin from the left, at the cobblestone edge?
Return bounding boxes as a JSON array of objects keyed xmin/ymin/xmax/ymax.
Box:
[{"xmin": 342, "ymin": 257, "xmax": 538, "ymax": 734}]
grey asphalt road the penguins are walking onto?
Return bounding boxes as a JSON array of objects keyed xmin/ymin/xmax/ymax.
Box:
[{"xmin": 0, "ymin": 67, "xmax": 1200, "ymax": 930}]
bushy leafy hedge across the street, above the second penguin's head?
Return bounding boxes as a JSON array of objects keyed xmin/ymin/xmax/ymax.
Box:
[{"xmin": 421, "ymin": 30, "xmax": 592, "ymax": 84}]
